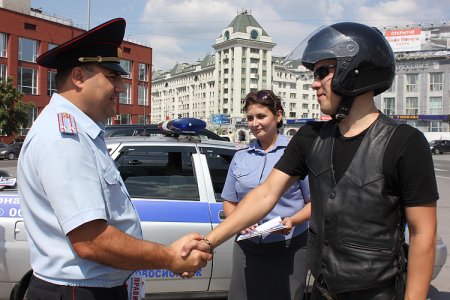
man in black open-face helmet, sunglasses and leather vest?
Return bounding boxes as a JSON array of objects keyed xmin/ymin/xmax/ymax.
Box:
[{"xmin": 184, "ymin": 23, "xmax": 439, "ymax": 300}]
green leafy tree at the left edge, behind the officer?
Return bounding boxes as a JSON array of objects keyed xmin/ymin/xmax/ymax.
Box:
[{"xmin": 0, "ymin": 77, "xmax": 34, "ymax": 135}]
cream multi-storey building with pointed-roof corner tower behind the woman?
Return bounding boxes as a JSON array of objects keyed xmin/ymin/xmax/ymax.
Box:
[{"xmin": 152, "ymin": 11, "xmax": 320, "ymax": 136}]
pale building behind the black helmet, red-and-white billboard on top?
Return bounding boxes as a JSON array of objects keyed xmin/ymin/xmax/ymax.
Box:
[{"xmin": 375, "ymin": 22, "xmax": 450, "ymax": 132}]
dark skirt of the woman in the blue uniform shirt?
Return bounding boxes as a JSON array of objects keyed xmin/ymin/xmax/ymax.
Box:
[{"xmin": 228, "ymin": 231, "xmax": 307, "ymax": 300}]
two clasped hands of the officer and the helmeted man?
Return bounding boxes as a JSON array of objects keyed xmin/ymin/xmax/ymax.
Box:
[{"xmin": 166, "ymin": 233, "xmax": 214, "ymax": 278}]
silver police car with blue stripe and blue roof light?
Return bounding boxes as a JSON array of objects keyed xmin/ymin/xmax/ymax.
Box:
[{"xmin": 0, "ymin": 119, "xmax": 237, "ymax": 299}]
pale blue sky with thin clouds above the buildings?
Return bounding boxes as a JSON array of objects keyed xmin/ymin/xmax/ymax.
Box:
[{"xmin": 31, "ymin": 0, "xmax": 450, "ymax": 70}]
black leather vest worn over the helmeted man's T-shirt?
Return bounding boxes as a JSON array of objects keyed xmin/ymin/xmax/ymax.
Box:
[{"xmin": 307, "ymin": 113, "xmax": 405, "ymax": 293}]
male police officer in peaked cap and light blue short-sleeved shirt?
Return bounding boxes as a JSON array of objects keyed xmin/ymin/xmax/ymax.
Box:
[{"xmin": 18, "ymin": 18, "xmax": 211, "ymax": 300}]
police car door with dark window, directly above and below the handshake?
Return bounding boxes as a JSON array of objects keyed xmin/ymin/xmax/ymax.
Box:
[{"xmin": 117, "ymin": 145, "xmax": 211, "ymax": 293}]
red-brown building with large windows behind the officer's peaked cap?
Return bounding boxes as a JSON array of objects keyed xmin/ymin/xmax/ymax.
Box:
[{"xmin": 0, "ymin": 0, "xmax": 152, "ymax": 141}]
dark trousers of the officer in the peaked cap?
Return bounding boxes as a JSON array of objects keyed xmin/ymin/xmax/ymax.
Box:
[{"xmin": 24, "ymin": 275, "xmax": 128, "ymax": 300}]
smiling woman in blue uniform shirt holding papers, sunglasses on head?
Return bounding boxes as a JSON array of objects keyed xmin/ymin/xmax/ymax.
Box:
[{"xmin": 222, "ymin": 90, "xmax": 311, "ymax": 300}]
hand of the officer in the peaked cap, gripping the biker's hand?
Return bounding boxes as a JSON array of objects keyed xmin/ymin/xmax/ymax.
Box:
[{"xmin": 168, "ymin": 233, "xmax": 212, "ymax": 277}]
